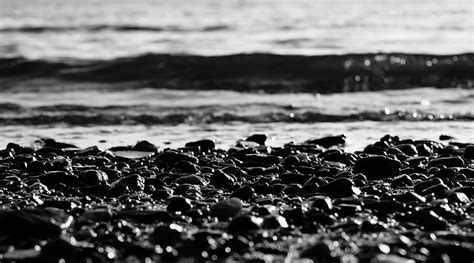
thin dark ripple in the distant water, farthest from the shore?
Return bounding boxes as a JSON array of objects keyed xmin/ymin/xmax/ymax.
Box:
[{"xmin": 0, "ymin": 24, "xmax": 232, "ymax": 34}]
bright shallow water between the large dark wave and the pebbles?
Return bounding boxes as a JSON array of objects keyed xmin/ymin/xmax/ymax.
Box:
[{"xmin": 0, "ymin": 88, "xmax": 474, "ymax": 151}]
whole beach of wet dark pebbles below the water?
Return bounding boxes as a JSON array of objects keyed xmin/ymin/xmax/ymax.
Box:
[{"xmin": 0, "ymin": 134, "xmax": 474, "ymax": 262}]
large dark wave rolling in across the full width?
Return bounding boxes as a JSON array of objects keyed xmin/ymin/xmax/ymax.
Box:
[{"xmin": 0, "ymin": 53, "xmax": 474, "ymax": 93}]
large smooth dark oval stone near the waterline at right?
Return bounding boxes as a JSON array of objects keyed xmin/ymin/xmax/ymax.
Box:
[{"xmin": 353, "ymin": 156, "xmax": 402, "ymax": 180}]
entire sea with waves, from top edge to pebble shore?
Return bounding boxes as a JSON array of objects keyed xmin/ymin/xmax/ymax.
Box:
[{"xmin": 0, "ymin": 0, "xmax": 474, "ymax": 150}]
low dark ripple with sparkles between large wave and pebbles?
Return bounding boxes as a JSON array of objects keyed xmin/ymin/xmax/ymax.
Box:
[{"xmin": 0, "ymin": 103, "xmax": 474, "ymax": 126}]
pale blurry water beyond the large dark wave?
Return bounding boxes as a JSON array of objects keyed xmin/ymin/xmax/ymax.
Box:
[{"xmin": 0, "ymin": 0, "xmax": 474, "ymax": 59}]
